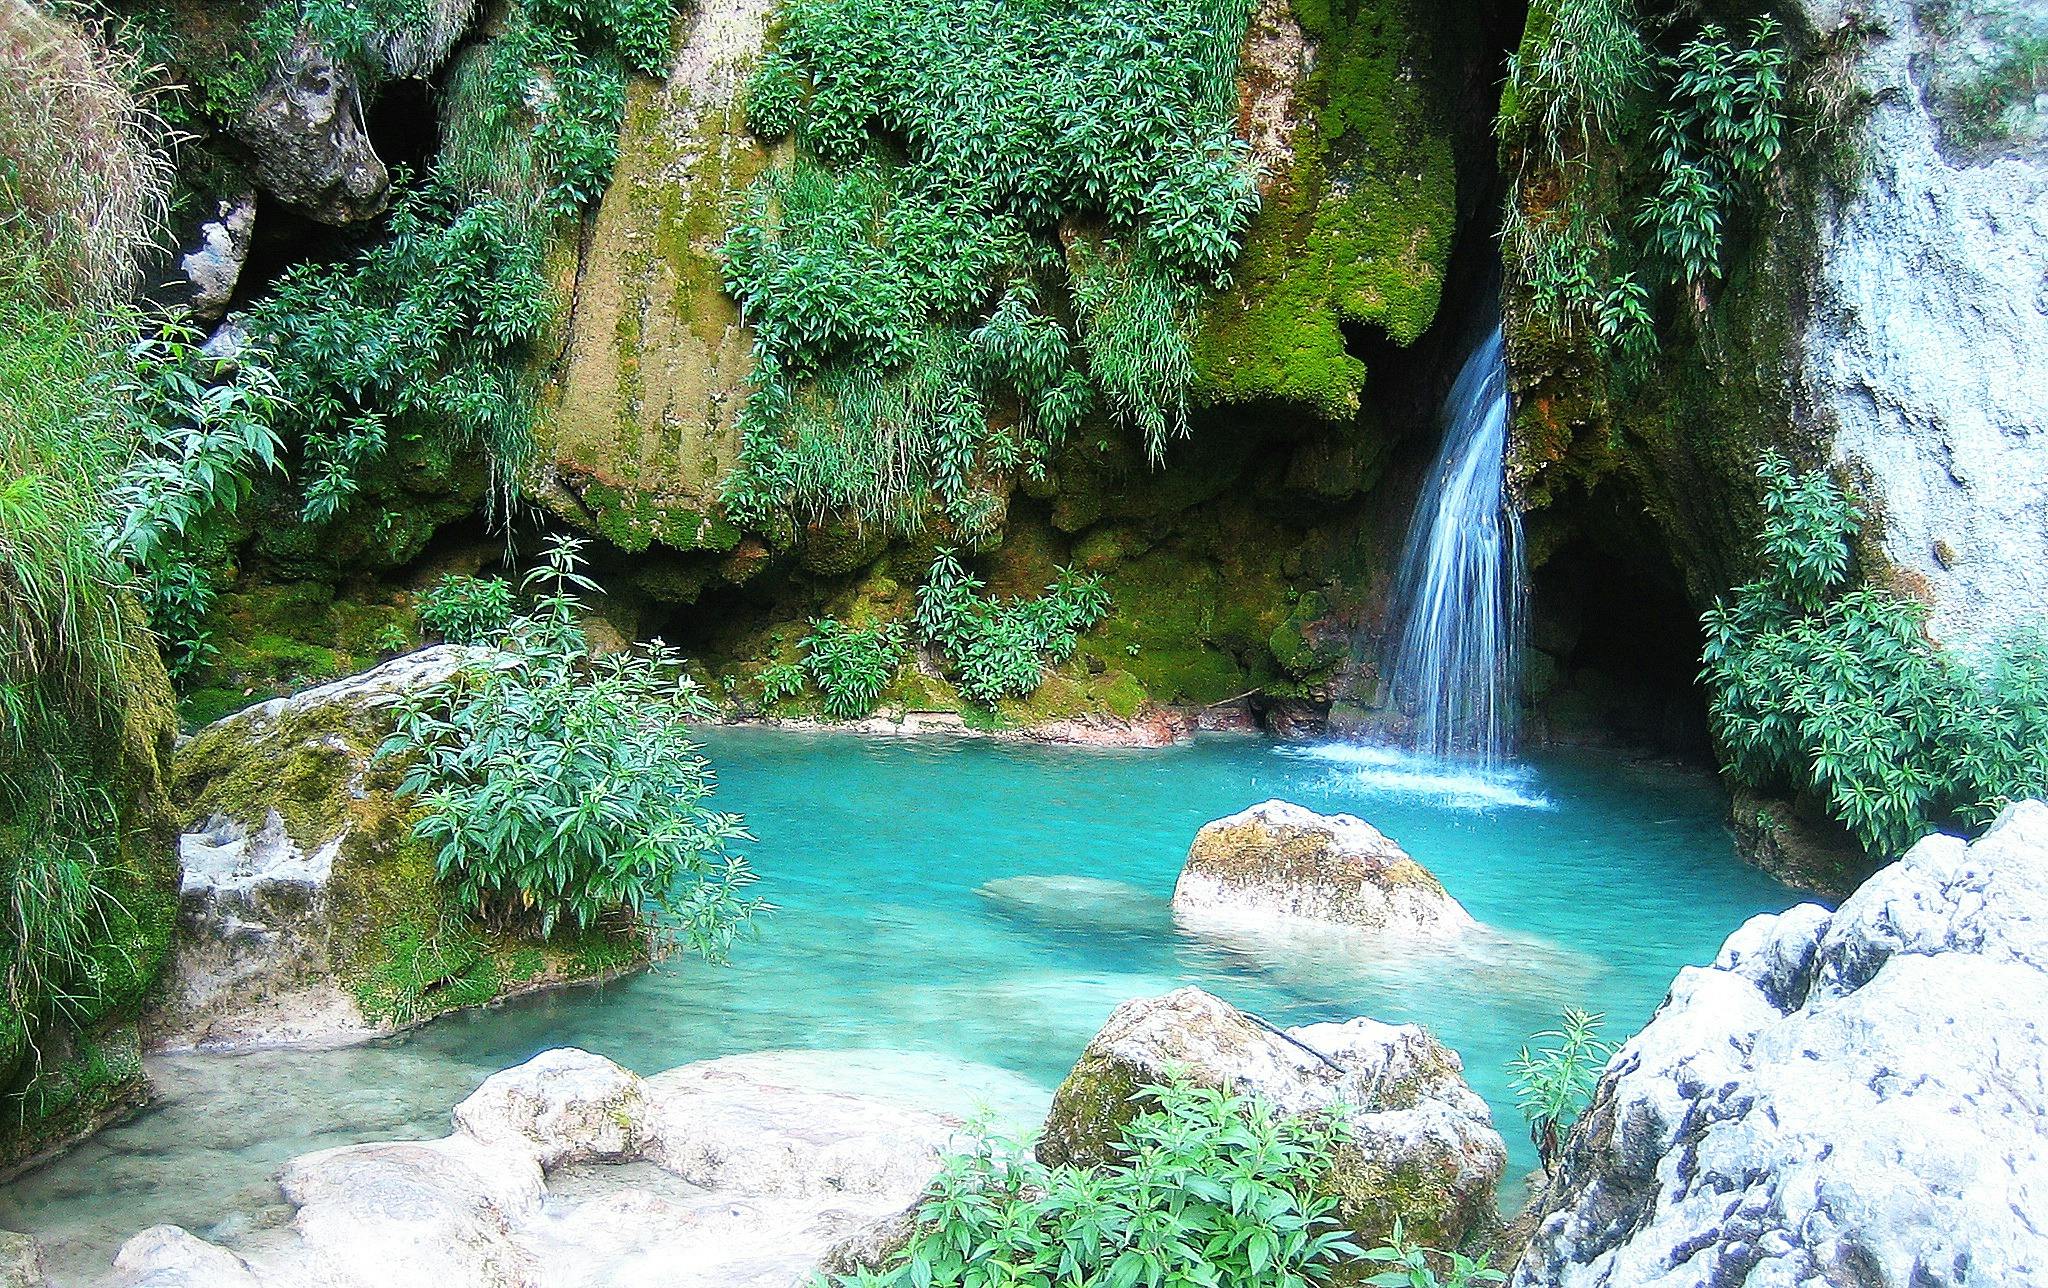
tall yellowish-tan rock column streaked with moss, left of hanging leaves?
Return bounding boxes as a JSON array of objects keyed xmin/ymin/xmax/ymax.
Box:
[{"xmin": 537, "ymin": 0, "xmax": 774, "ymax": 551}]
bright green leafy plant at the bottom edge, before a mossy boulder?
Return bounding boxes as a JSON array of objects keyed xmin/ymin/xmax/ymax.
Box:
[{"xmin": 836, "ymin": 1083, "xmax": 1358, "ymax": 1288}]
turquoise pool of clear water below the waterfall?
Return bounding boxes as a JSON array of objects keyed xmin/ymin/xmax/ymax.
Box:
[{"xmin": 0, "ymin": 729, "xmax": 1794, "ymax": 1284}]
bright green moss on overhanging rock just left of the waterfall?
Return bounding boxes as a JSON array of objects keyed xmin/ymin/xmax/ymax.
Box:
[{"xmin": 1194, "ymin": 0, "xmax": 1456, "ymax": 420}]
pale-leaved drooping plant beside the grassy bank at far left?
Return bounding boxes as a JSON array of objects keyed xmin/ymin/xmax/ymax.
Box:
[{"xmin": 115, "ymin": 321, "xmax": 283, "ymax": 678}]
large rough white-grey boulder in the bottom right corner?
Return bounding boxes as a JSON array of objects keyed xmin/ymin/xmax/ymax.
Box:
[{"xmin": 1513, "ymin": 803, "xmax": 2048, "ymax": 1288}]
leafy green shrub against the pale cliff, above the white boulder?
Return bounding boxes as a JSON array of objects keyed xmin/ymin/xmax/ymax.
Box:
[{"xmin": 1702, "ymin": 455, "xmax": 2048, "ymax": 856}]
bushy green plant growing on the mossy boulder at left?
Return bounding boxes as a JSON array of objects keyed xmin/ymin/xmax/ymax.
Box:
[{"xmin": 381, "ymin": 539, "xmax": 762, "ymax": 958}]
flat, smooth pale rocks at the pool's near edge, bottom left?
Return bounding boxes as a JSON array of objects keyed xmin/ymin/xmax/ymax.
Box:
[{"xmin": 105, "ymin": 1050, "xmax": 954, "ymax": 1288}]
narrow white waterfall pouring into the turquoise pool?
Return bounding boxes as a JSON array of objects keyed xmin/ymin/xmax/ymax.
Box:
[{"xmin": 1393, "ymin": 326, "xmax": 1528, "ymax": 766}]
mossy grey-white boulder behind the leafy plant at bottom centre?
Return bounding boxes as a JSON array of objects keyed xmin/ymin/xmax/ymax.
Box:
[{"xmin": 1038, "ymin": 989, "xmax": 1507, "ymax": 1247}]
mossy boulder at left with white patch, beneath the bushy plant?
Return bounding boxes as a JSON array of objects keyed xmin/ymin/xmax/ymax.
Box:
[{"xmin": 147, "ymin": 645, "xmax": 647, "ymax": 1046}]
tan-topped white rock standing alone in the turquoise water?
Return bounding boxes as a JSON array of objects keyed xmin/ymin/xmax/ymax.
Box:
[{"xmin": 1174, "ymin": 801, "xmax": 1477, "ymax": 934}]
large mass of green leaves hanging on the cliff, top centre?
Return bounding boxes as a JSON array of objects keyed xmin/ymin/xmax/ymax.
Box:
[{"xmin": 725, "ymin": 0, "xmax": 1257, "ymax": 530}]
